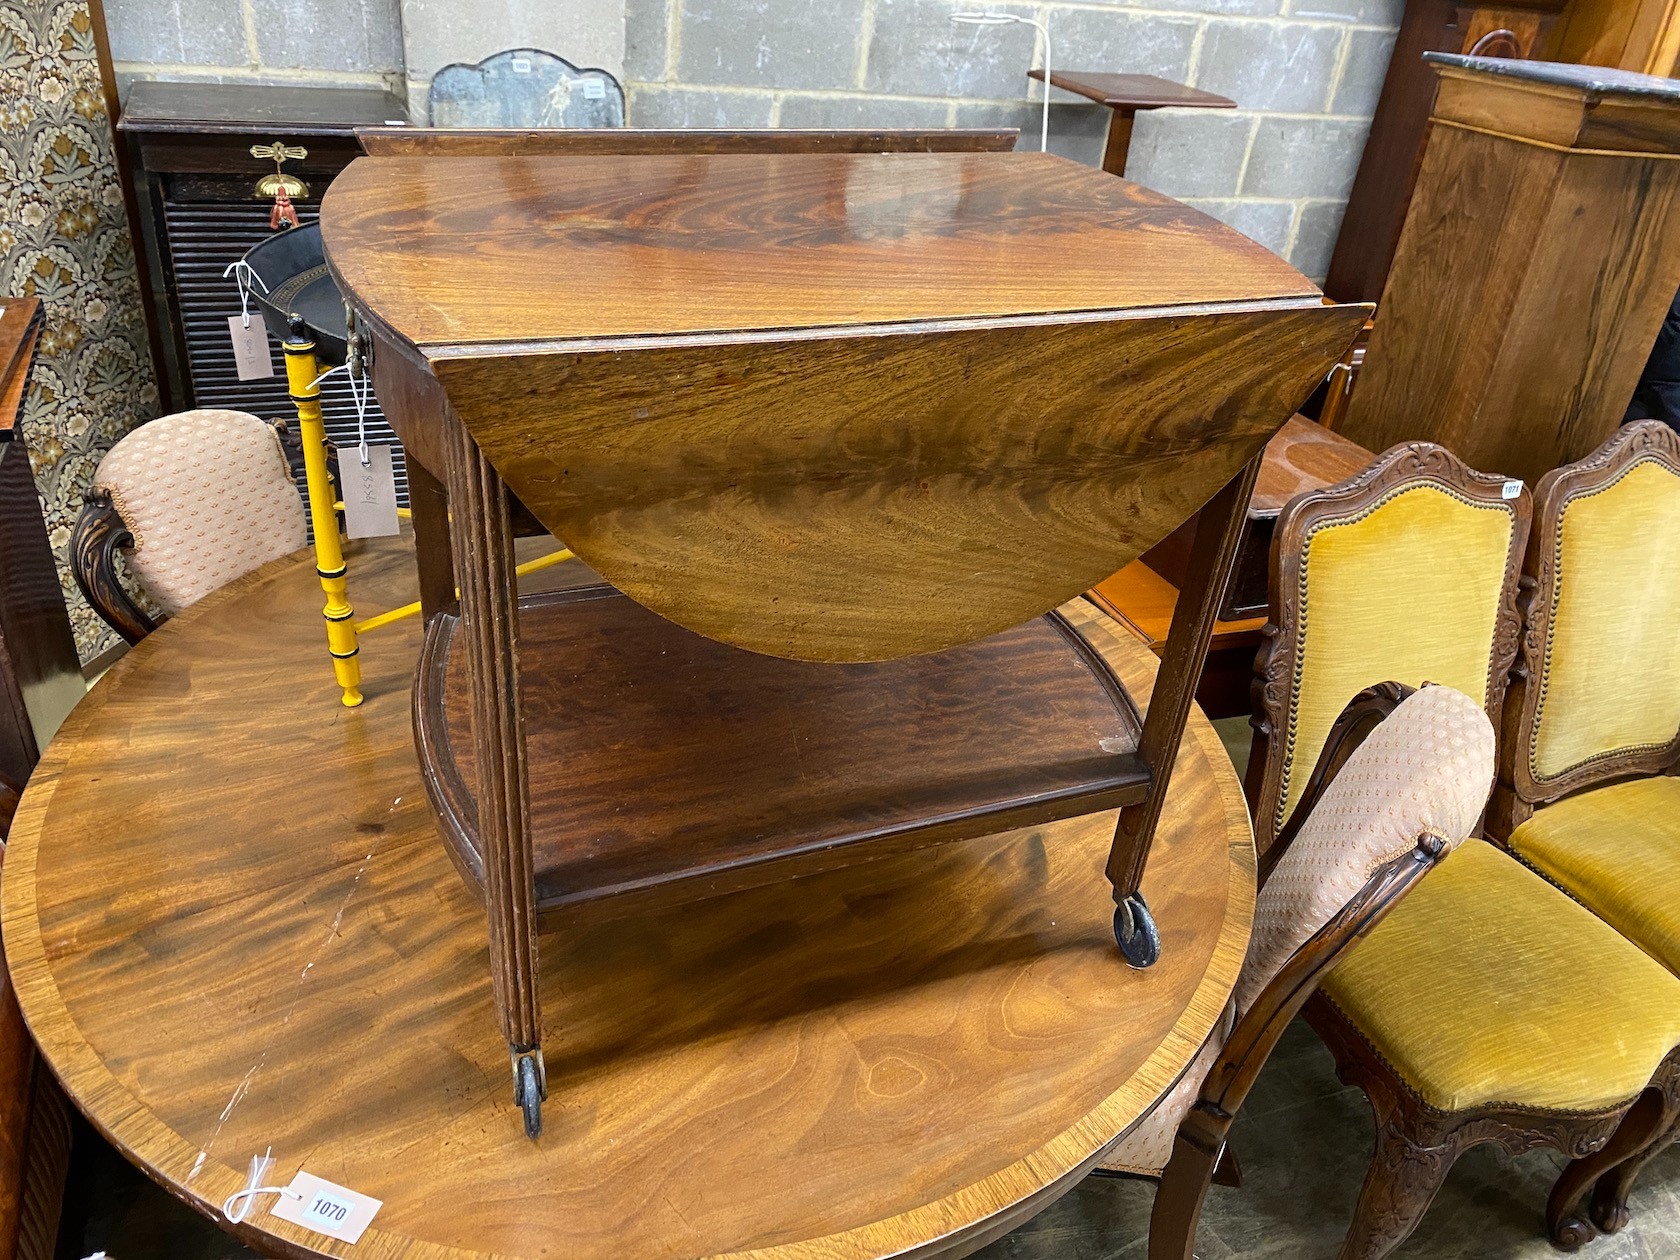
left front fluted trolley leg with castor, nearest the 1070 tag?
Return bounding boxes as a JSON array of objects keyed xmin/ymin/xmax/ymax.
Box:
[{"xmin": 449, "ymin": 417, "xmax": 548, "ymax": 1137}]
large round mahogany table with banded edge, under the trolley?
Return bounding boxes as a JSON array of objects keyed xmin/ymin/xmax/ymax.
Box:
[{"xmin": 3, "ymin": 539, "xmax": 1255, "ymax": 1260}]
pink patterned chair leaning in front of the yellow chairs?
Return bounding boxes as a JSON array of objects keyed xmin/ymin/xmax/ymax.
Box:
[{"xmin": 1099, "ymin": 682, "xmax": 1494, "ymax": 1260}]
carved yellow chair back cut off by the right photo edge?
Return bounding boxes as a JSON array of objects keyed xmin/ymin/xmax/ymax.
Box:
[{"xmin": 1492, "ymin": 420, "xmax": 1680, "ymax": 837}]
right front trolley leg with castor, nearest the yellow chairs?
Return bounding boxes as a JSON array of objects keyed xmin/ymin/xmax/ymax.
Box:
[{"xmin": 1107, "ymin": 455, "xmax": 1262, "ymax": 968}]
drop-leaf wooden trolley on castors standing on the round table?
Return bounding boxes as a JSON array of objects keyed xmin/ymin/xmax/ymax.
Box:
[{"xmin": 321, "ymin": 153, "xmax": 1366, "ymax": 1136}]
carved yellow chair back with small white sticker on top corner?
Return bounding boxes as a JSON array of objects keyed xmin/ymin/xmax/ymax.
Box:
[{"xmin": 1245, "ymin": 442, "xmax": 1530, "ymax": 872}]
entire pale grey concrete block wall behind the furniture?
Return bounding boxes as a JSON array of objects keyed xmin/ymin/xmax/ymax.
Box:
[{"xmin": 106, "ymin": 0, "xmax": 1403, "ymax": 279}]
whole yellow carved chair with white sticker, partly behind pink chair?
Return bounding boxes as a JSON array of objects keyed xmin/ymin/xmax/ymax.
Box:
[{"xmin": 1248, "ymin": 444, "xmax": 1680, "ymax": 1260}]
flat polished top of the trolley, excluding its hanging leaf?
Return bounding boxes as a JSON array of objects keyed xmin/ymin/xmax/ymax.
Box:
[{"xmin": 321, "ymin": 153, "xmax": 1319, "ymax": 348}]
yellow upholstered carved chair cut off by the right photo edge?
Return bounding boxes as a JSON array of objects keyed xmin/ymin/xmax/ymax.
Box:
[{"xmin": 1490, "ymin": 420, "xmax": 1680, "ymax": 1230}]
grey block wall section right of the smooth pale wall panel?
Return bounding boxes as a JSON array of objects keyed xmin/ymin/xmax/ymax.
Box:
[{"xmin": 625, "ymin": 0, "xmax": 1403, "ymax": 279}]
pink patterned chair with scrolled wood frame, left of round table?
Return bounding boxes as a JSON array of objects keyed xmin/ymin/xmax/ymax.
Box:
[{"xmin": 71, "ymin": 410, "xmax": 307, "ymax": 643}]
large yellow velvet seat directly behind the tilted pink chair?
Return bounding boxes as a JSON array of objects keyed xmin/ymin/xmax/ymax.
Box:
[{"xmin": 1322, "ymin": 840, "xmax": 1680, "ymax": 1110}]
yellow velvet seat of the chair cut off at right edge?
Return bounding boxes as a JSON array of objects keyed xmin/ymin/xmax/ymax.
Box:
[{"xmin": 1510, "ymin": 778, "xmax": 1680, "ymax": 973}]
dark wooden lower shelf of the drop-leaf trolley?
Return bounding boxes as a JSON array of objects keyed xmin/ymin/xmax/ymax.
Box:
[{"xmin": 415, "ymin": 586, "xmax": 1149, "ymax": 916}]
